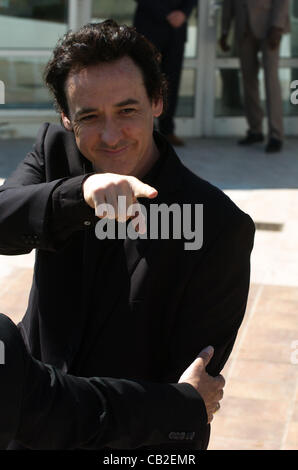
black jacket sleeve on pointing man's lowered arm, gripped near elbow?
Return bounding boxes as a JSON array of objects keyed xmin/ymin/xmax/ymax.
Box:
[{"xmin": 166, "ymin": 211, "xmax": 255, "ymax": 381}]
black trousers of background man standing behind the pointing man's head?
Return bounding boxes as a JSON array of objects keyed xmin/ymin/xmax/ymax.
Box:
[{"xmin": 134, "ymin": 10, "xmax": 186, "ymax": 135}]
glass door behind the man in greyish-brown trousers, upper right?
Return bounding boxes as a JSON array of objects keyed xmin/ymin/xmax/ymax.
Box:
[{"xmin": 199, "ymin": 0, "xmax": 298, "ymax": 136}]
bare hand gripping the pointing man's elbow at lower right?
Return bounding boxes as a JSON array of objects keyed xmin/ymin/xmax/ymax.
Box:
[{"xmin": 179, "ymin": 346, "xmax": 225, "ymax": 423}]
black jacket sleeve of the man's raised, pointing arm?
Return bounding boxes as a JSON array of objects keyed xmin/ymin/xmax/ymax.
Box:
[{"xmin": 0, "ymin": 124, "xmax": 95, "ymax": 255}]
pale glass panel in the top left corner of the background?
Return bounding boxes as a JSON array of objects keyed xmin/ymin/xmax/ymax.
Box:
[{"xmin": 0, "ymin": 0, "xmax": 68, "ymax": 49}]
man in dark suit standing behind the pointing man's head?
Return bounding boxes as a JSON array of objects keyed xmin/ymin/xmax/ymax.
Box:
[{"xmin": 134, "ymin": 0, "xmax": 197, "ymax": 146}]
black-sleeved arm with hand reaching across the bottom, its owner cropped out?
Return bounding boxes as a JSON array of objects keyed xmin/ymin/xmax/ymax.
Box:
[{"xmin": 0, "ymin": 314, "xmax": 224, "ymax": 450}]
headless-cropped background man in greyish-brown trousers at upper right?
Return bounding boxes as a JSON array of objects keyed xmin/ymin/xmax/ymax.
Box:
[{"xmin": 220, "ymin": 0, "xmax": 289, "ymax": 153}]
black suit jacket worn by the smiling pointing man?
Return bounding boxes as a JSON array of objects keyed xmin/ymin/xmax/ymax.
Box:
[{"xmin": 0, "ymin": 124, "xmax": 254, "ymax": 446}]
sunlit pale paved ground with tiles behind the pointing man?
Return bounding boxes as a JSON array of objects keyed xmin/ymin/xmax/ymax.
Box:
[{"xmin": 0, "ymin": 135, "xmax": 298, "ymax": 450}]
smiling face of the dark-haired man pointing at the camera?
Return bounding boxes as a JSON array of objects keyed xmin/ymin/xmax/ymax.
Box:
[{"xmin": 62, "ymin": 57, "xmax": 162, "ymax": 177}]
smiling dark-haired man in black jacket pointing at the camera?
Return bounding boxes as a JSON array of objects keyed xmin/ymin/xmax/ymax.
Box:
[{"xmin": 0, "ymin": 20, "xmax": 254, "ymax": 449}]
